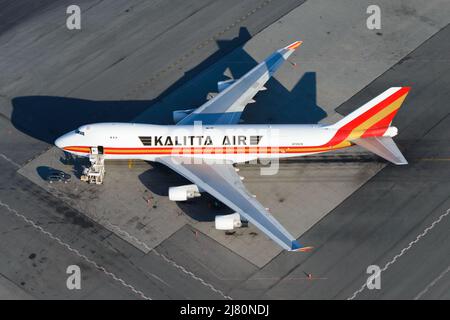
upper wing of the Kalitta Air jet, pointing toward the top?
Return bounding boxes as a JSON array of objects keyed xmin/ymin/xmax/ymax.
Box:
[{"xmin": 177, "ymin": 41, "xmax": 302, "ymax": 125}]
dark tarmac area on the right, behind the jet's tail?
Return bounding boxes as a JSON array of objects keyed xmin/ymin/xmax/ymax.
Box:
[{"xmin": 232, "ymin": 22, "xmax": 450, "ymax": 299}]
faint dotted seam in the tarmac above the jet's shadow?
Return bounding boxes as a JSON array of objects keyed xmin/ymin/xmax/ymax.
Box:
[{"xmin": 125, "ymin": 0, "xmax": 273, "ymax": 98}]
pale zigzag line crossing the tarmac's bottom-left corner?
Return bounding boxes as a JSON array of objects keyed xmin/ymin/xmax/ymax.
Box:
[{"xmin": 0, "ymin": 200, "xmax": 152, "ymax": 300}]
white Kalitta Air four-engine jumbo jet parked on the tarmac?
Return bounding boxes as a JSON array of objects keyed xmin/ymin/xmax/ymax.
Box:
[{"xmin": 55, "ymin": 41, "xmax": 409, "ymax": 251}]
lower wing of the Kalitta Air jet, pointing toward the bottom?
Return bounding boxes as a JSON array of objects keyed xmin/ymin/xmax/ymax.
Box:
[{"xmin": 156, "ymin": 156, "xmax": 311, "ymax": 251}]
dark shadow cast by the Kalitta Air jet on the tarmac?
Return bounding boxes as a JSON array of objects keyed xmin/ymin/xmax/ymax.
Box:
[{"xmin": 11, "ymin": 28, "xmax": 326, "ymax": 220}]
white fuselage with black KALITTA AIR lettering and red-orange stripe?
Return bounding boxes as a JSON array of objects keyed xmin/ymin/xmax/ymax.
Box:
[{"xmin": 55, "ymin": 123, "xmax": 360, "ymax": 163}]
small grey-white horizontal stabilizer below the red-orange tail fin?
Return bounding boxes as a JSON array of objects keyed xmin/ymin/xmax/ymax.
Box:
[{"xmin": 352, "ymin": 137, "xmax": 408, "ymax": 165}]
